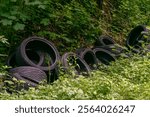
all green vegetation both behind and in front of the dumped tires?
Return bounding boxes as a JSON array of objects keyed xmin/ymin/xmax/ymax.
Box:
[{"xmin": 0, "ymin": 0, "xmax": 150, "ymax": 99}]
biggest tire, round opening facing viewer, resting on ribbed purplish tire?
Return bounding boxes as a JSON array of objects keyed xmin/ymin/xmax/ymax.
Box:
[{"xmin": 16, "ymin": 37, "xmax": 60, "ymax": 71}]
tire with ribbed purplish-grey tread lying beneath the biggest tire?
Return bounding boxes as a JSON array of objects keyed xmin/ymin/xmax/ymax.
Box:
[{"xmin": 9, "ymin": 66, "xmax": 47, "ymax": 84}]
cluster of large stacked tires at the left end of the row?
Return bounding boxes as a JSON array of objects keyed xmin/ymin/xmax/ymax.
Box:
[{"xmin": 7, "ymin": 37, "xmax": 60, "ymax": 86}]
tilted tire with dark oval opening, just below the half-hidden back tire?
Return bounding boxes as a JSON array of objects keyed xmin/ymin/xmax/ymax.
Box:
[{"xmin": 93, "ymin": 48, "xmax": 117, "ymax": 65}]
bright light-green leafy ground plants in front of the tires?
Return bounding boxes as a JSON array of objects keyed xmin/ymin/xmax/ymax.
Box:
[{"xmin": 0, "ymin": 55, "xmax": 150, "ymax": 100}]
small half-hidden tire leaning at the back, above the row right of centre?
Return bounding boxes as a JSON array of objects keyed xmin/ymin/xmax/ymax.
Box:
[{"xmin": 94, "ymin": 35, "xmax": 115, "ymax": 46}]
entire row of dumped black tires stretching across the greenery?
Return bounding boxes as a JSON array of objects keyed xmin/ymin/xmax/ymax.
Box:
[{"xmin": 7, "ymin": 25, "xmax": 150, "ymax": 89}]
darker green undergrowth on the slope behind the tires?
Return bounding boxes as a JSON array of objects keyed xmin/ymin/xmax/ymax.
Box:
[{"xmin": 0, "ymin": 0, "xmax": 150, "ymax": 54}]
